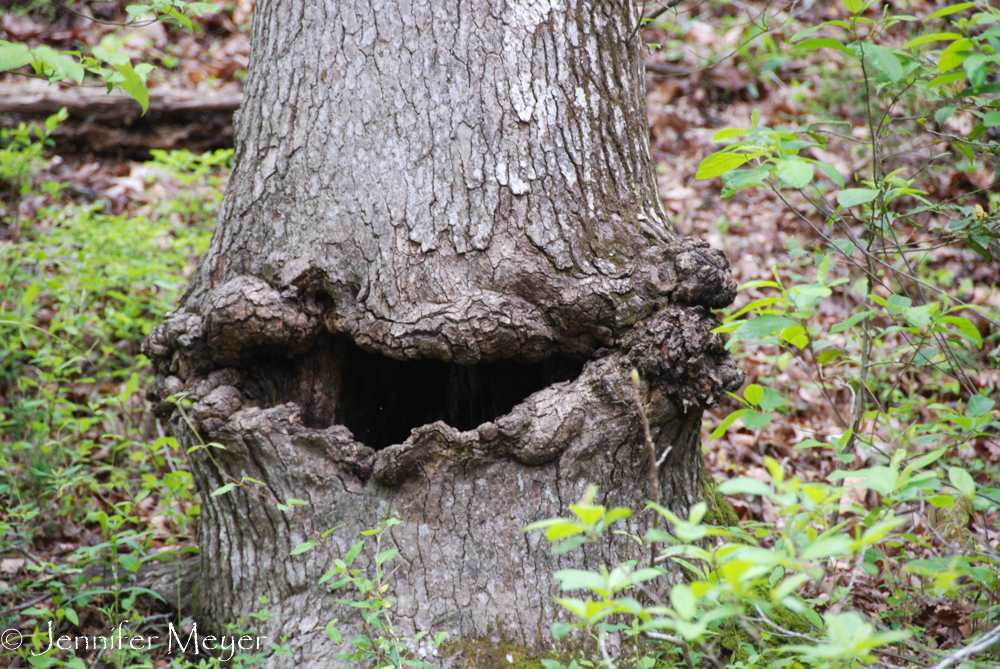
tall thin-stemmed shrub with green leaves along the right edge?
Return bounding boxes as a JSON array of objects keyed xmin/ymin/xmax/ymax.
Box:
[{"xmin": 697, "ymin": 0, "xmax": 1000, "ymax": 665}]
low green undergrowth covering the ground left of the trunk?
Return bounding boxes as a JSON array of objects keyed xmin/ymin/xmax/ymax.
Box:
[{"xmin": 0, "ymin": 109, "xmax": 231, "ymax": 668}]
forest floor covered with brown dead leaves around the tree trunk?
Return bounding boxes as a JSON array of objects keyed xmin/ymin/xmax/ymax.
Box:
[{"xmin": 0, "ymin": 0, "xmax": 1000, "ymax": 666}]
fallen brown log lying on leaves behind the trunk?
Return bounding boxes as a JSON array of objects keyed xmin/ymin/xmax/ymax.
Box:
[{"xmin": 0, "ymin": 79, "xmax": 243, "ymax": 159}]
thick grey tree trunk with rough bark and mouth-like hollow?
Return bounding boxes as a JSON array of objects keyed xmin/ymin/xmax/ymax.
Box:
[{"xmin": 147, "ymin": 0, "xmax": 742, "ymax": 667}]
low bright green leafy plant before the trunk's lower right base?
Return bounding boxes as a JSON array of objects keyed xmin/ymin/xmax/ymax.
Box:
[{"xmin": 525, "ymin": 480, "xmax": 910, "ymax": 669}]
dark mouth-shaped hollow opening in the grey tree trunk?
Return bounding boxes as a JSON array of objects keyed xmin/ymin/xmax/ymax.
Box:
[{"xmin": 246, "ymin": 336, "xmax": 584, "ymax": 449}]
